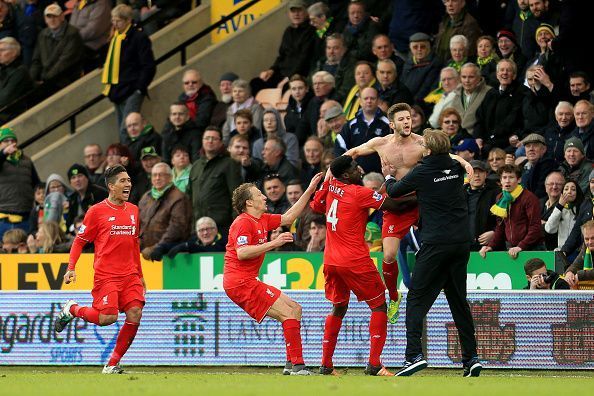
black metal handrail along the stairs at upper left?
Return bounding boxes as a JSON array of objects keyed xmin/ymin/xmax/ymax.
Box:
[{"xmin": 19, "ymin": 0, "xmax": 260, "ymax": 148}]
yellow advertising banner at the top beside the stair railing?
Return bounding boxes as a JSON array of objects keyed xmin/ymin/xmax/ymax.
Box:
[{"xmin": 210, "ymin": 0, "xmax": 281, "ymax": 44}]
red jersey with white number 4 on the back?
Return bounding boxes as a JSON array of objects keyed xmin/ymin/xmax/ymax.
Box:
[{"xmin": 311, "ymin": 179, "xmax": 385, "ymax": 267}]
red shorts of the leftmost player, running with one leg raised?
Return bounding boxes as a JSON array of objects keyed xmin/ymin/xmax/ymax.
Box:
[{"xmin": 91, "ymin": 275, "xmax": 145, "ymax": 315}]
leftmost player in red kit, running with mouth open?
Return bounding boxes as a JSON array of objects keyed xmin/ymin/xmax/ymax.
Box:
[{"xmin": 55, "ymin": 165, "xmax": 146, "ymax": 374}]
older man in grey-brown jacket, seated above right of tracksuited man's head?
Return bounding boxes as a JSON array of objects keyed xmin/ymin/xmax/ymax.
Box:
[{"xmin": 452, "ymin": 63, "xmax": 491, "ymax": 136}]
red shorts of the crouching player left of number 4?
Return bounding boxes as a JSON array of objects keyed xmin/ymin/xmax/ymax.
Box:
[{"xmin": 225, "ymin": 278, "xmax": 281, "ymax": 323}]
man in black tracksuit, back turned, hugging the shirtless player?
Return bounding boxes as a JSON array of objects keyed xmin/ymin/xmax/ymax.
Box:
[{"xmin": 382, "ymin": 131, "xmax": 482, "ymax": 377}]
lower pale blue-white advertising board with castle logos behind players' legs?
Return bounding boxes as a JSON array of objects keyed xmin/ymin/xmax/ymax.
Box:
[{"xmin": 0, "ymin": 291, "xmax": 594, "ymax": 369}]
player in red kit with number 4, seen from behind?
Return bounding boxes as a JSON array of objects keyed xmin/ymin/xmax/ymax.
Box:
[{"xmin": 311, "ymin": 155, "xmax": 416, "ymax": 376}]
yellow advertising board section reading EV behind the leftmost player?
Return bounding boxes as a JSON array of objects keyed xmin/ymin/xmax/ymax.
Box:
[{"xmin": 0, "ymin": 254, "xmax": 163, "ymax": 290}]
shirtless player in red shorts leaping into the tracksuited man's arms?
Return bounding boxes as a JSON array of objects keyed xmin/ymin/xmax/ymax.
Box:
[{"xmin": 344, "ymin": 103, "xmax": 472, "ymax": 323}]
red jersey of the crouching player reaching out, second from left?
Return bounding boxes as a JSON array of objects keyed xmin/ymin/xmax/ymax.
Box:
[{"xmin": 223, "ymin": 213, "xmax": 281, "ymax": 289}]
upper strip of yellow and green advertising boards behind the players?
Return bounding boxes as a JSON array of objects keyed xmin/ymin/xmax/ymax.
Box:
[{"xmin": 0, "ymin": 252, "xmax": 555, "ymax": 291}]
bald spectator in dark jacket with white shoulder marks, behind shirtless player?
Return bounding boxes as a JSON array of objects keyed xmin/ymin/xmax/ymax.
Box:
[{"xmin": 334, "ymin": 88, "xmax": 392, "ymax": 173}]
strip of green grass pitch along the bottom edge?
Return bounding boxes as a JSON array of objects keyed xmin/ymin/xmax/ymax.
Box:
[{"xmin": 0, "ymin": 366, "xmax": 594, "ymax": 396}]
